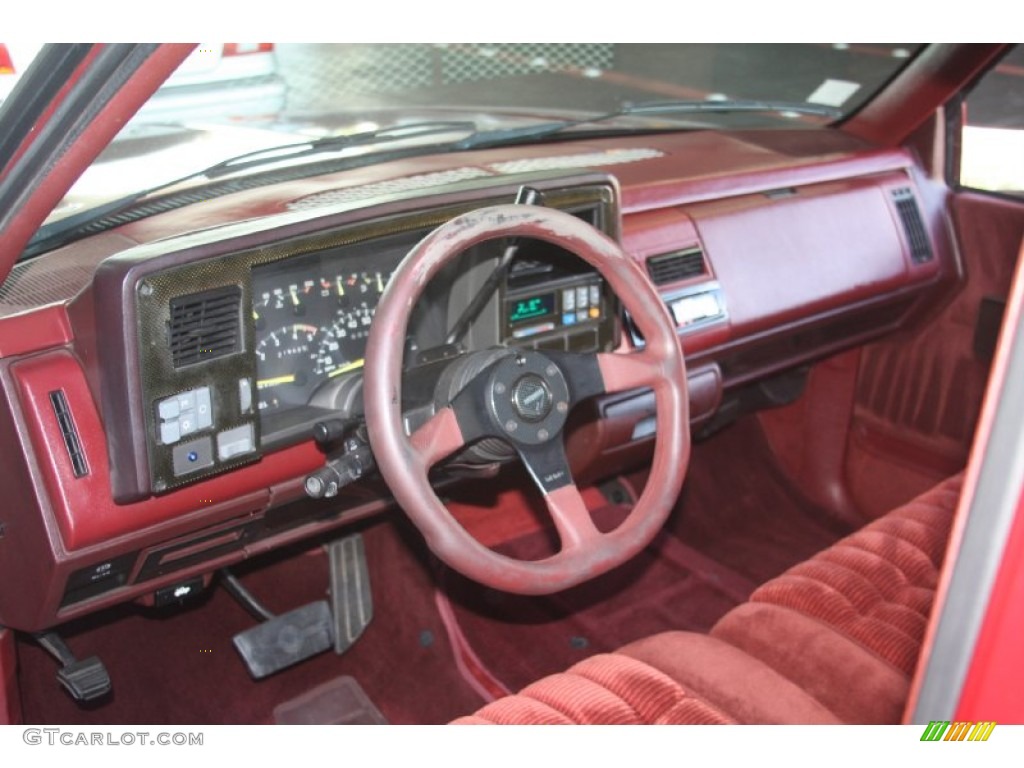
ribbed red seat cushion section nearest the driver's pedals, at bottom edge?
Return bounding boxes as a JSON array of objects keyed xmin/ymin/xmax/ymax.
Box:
[{"xmin": 455, "ymin": 653, "xmax": 733, "ymax": 725}]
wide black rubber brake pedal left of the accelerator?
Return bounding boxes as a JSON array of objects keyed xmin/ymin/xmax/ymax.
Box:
[{"xmin": 231, "ymin": 600, "xmax": 333, "ymax": 680}]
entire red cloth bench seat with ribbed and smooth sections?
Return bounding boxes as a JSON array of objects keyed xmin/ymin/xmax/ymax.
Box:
[{"xmin": 456, "ymin": 475, "xmax": 963, "ymax": 725}]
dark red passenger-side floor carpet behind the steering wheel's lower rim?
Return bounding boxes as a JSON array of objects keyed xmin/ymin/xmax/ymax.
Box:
[{"xmin": 444, "ymin": 420, "xmax": 848, "ymax": 689}]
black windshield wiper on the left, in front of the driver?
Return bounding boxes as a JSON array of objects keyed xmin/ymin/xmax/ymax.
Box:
[{"xmin": 22, "ymin": 120, "xmax": 476, "ymax": 258}]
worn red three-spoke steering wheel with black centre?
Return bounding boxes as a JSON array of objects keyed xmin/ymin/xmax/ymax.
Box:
[{"xmin": 364, "ymin": 205, "xmax": 690, "ymax": 595}]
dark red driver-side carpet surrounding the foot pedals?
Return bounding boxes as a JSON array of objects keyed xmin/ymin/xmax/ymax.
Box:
[{"xmin": 18, "ymin": 521, "xmax": 483, "ymax": 724}]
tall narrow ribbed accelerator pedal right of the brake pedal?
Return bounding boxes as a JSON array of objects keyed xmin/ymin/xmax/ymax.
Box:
[{"xmin": 327, "ymin": 534, "xmax": 374, "ymax": 653}]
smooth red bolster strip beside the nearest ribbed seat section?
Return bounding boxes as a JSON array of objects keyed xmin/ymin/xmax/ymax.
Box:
[{"xmin": 618, "ymin": 632, "xmax": 842, "ymax": 724}]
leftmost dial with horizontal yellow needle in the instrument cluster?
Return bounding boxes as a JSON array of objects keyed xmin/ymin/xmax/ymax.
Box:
[{"xmin": 256, "ymin": 323, "xmax": 319, "ymax": 410}]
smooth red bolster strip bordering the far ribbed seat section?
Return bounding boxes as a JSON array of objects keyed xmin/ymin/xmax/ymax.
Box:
[{"xmin": 712, "ymin": 603, "xmax": 909, "ymax": 724}]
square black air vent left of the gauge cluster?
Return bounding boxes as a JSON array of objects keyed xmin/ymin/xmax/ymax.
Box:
[{"xmin": 168, "ymin": 286, "xmax": 242, "ymax": 368}]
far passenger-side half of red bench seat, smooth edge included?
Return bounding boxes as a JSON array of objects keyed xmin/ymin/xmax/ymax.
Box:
[{"xmin": 712, "ymin": 475, "xmax": 963, "ymax": 723}]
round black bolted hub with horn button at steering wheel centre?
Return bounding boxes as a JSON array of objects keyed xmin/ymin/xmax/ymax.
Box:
[{"xmin": 487, "ymin": 350, "xmax": 569, "ymax": 445}]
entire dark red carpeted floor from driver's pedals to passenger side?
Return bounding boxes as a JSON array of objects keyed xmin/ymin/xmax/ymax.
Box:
[{"xmin": 18, "ymin": 421, "xmax": 845, "ymax": 724}]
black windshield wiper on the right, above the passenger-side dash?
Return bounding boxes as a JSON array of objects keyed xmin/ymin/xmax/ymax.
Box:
[{"xmin": 456, "ymin": 99, "xmax": 843, "ymax": 150}]
